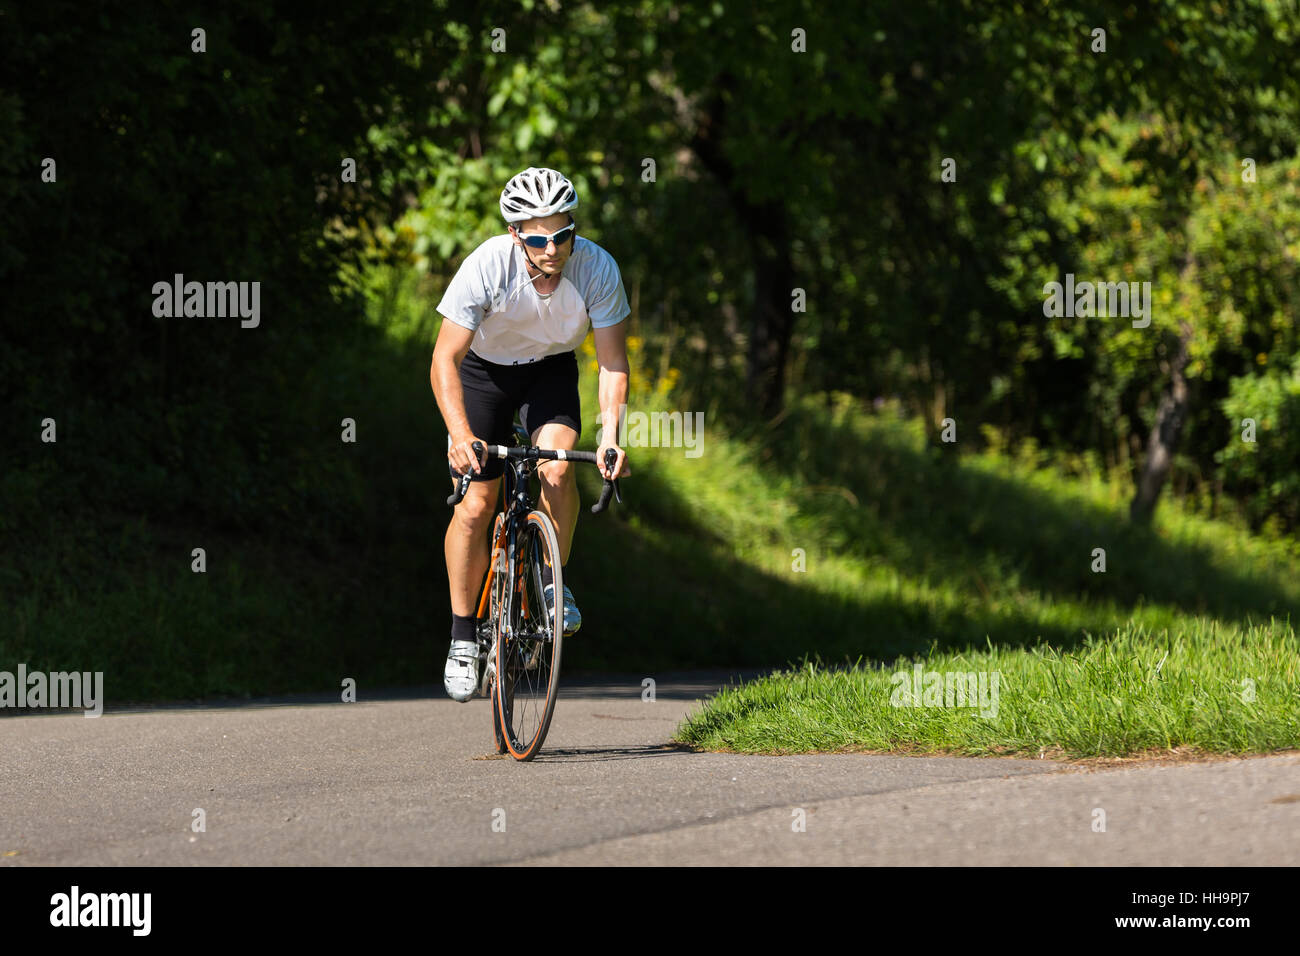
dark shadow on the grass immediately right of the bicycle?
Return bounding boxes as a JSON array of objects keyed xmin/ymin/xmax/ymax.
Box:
[{"xmin": 564, "ymin": 470, "xmax": 1081, "ymax": 679}]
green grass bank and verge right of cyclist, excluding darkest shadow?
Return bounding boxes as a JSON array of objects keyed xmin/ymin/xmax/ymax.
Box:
[{"xmin": 644, "ymin": 392, "xmax": 1300, "ymax": 756}]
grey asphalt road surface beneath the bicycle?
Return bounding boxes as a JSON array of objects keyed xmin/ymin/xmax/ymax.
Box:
[{"xmin": 0, "ymin": 674, "xmax": 1300, "ymax": 866}]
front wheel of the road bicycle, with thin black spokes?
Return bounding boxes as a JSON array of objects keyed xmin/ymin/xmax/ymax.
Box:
[{"xmin": 495, "ymin": 511, "xmax": 564, "ymax": 761}]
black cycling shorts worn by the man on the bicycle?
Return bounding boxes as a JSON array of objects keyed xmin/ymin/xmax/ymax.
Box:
[{"xmin": 447, "ymin": 350, "xmax": 582, "ymax": 481}]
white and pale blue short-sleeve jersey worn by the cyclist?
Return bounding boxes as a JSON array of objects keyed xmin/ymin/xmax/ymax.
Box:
[{"xmin": 438, "ymin": 233, "xmax": 632, "ymax": 365}]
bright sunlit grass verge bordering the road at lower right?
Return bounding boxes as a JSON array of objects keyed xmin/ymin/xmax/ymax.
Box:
[{"xmin": 677, "ymin": 620, "xmax": 1300, "ymax": 758}]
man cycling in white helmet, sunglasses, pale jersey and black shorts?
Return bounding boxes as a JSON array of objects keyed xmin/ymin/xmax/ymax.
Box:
[{"xmin": 429, "ymin": 166, "xmax": 632, "ymax": 701}]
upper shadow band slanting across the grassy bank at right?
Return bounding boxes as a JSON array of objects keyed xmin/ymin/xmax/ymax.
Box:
[{"xmin": 766, "ymin": 408, "xmax": 1300, "ymax": 623}]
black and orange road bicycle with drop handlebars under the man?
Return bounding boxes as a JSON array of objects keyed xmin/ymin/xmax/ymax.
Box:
[{"xmin": 447, "ymin": 424, "xmax": 623, "ymax": 761}]
